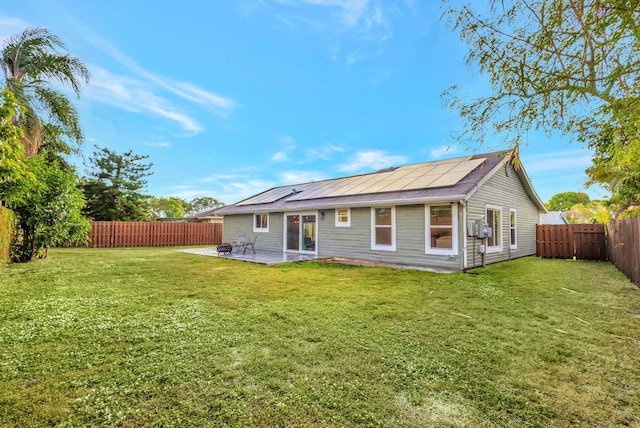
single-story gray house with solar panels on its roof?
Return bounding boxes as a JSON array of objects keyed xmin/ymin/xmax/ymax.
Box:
[{"xmin": 216, "ymin": 152, "xmax": 546, "ymax": 270}]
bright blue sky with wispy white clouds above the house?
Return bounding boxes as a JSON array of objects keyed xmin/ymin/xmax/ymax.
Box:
[{"xmin": 0, "ymin": 0, "xmax": 605, "ymax": 203}]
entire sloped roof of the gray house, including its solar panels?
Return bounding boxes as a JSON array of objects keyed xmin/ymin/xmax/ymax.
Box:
[{"xmin": 215, "ymin": 152, "xmax": 546, "ymax": 215}]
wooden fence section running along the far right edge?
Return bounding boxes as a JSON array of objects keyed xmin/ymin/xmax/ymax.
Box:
[{"xmin": 607, "ymin": 217, "xmax": 640, "ymax": 287}]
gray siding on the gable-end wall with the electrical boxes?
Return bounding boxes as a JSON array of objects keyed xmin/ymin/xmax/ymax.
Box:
[{"xmin": 467, "ymin": 167, "xmax": 540, "ymax": 267}]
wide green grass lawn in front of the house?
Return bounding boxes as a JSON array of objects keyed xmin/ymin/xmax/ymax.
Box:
[{"xmin": 0, "ymin": 248, "xmax": 640, "ymax": 427}]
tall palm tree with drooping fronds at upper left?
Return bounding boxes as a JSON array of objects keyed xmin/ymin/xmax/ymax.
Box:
[{"xmin": 0, "ymin": 28, "xmax": 89, "ymax": 156}]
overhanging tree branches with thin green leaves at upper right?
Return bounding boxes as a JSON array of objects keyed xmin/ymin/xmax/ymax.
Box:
[{"xmin": 444, "ymin": 0, "xmax": 640, "ymax": 214}]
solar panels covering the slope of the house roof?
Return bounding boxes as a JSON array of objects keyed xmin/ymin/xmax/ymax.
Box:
[{"xmin": 238, "ymin": 158, "xmax": 484, "ymax": 205}]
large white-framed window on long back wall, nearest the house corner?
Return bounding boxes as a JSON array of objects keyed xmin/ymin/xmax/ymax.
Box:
[{"xmin": 425, "ymin": 204, "xmax": 458, "ymax": 256}]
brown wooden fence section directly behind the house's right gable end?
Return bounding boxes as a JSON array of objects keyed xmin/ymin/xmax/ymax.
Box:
[{"xmin": 536, "ymin": 224, "xmax": 607, "ymax": 260}]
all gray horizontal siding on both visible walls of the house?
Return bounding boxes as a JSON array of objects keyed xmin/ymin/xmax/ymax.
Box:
[{"xmin": 223, "ymin": 164, "xmax": 540, "ymax": 270}]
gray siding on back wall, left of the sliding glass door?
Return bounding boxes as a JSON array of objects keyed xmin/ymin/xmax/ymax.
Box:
[{"xmin": 222, "ymin": 213, "xmax": 284, "ymax": 251}]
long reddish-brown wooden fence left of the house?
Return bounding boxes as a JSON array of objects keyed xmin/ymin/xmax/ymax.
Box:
[{"xmin": 87, "ymin": 221, "xmax": 222, "ymax": 248}]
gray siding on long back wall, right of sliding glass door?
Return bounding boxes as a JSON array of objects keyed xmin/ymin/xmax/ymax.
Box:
[{"xmin": 318, "ymin": 205, "xmax": 462, "ymax": 269}]
